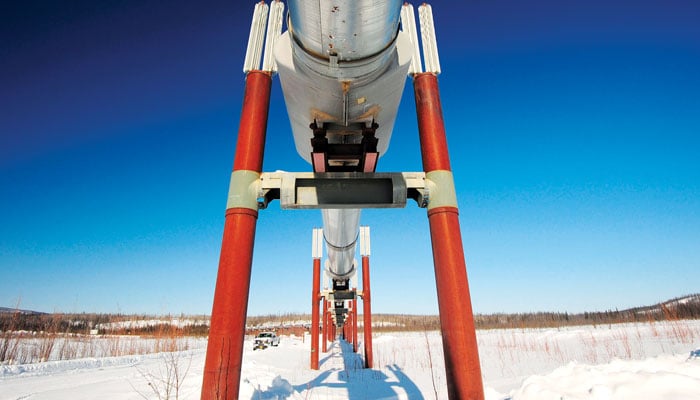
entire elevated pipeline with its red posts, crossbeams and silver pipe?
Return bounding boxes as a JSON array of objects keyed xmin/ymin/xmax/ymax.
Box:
[{"xmin": 201, "ymin": 0, "xmax": 484, "ymax": 400}]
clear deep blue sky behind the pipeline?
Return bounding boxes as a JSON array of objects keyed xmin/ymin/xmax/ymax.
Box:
[{"xmin": 0, "ymin": 0, "xmax": 700, "ymax": 314}]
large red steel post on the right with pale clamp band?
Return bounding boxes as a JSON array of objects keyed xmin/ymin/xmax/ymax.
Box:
[{"xmin": 413, "ymin": 73, "xmax": 484, "ymax": 400}]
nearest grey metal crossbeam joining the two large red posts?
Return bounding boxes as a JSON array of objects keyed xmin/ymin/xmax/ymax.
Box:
[{"xmin": 257, "ymin": 172, "xmax": 430, "ymax": 209}]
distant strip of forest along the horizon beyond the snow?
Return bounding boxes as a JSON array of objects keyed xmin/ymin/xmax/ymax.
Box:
[{"xmin": 0, "ymin": 294, "xmax": 700, "ymax": 336}]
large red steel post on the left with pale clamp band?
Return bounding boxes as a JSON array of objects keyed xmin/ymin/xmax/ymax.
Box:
[{"xmin": 201, "ymin": 71, "xmax": 272, "ymax": 400}]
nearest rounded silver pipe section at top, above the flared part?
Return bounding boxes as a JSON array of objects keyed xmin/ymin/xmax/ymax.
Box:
[{"xmin": 288, "ymin": 0, "xmax": 402, "ymax": 61}]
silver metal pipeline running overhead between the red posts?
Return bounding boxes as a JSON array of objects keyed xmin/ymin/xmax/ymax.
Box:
[{"xmin": 275, "ymin": 0, "xmax": 413, "ymax": 279}]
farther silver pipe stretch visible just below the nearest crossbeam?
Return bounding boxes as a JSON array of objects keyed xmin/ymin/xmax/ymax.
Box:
[{"xmin": 321, "ymin": 209, "xmax": 360, "ymax": 279}]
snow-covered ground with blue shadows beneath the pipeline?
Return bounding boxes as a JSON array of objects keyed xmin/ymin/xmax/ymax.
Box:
[{"xmin": 0, "ymin": 321, "xmax": 700, "ymax": 400}]
